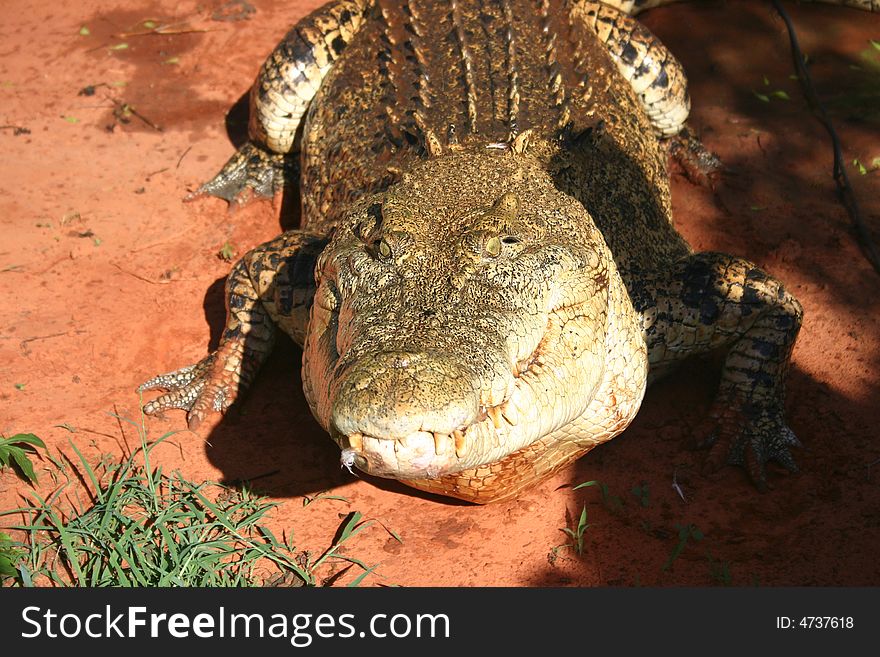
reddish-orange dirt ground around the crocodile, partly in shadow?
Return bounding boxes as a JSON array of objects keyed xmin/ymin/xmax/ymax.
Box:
[{"xmin": 0, "ymin": 0, "xmax": 880, "ymax": 587}]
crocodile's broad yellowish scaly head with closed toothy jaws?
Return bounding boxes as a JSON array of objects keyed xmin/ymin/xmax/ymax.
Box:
[{"xmin": 303, "ymin": 151, "xmax": 644, "ymax": 501}]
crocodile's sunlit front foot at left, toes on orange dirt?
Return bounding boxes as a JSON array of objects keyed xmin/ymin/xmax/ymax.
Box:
[{"xmin": 138, "ymin": 340, "xmax": 248, "ymax": 430}]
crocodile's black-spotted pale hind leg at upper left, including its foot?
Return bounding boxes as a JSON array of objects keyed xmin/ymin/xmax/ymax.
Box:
[{"xmin": 187, "ymin": 0, "xmax": 373, "ymax": 203}]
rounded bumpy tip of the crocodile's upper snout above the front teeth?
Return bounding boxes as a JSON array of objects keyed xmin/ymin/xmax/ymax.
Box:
[{"xmin": 330, "ymin": 351, "xmax": 480, "ymax": 440}]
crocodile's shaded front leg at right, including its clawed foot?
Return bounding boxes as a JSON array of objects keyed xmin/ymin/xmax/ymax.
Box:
[{"xmin": 633, "ymin": 253, "xmax": 803, "ymax": 490}]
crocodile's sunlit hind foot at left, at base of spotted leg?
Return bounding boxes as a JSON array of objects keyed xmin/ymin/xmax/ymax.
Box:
[{"xmin": 184, "ymin": 142, "xmax": 286, "ymax": 205}]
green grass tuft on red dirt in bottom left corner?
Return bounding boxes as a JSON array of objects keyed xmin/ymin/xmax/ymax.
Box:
[{"xmin": 0, "ymin": 422, "xmax": 375, "ymax": 587}]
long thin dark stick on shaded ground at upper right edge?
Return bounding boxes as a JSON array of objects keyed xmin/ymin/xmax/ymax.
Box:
[{"xmin": 772, "ymin": 0, "xmax": 880, "ymax": 274}]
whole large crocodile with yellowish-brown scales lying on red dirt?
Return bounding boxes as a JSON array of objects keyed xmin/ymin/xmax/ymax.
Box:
[{"xmin": 140, "ymin": 0, "xmax": 880, "ymax": 504}]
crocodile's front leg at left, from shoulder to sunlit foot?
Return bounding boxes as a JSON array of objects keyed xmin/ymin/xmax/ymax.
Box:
[{"xmin": 138, "ymin": 230, "xmax": 327, "ymax": 429}]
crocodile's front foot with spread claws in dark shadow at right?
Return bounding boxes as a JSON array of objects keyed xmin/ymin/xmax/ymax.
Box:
[{"xmin": 701, "ymin": 392, "xmax": 802, "ymax": 492}]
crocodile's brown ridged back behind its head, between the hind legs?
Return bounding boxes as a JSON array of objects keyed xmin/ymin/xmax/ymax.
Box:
[{"xmin": 302, "ymin": 0, "xmax": 687, "ymax": 274}]
